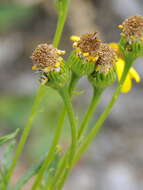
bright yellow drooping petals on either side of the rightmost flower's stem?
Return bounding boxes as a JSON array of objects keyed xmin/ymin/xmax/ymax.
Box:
[{"xmin": 116, "ymin": 58, "xmax": 140, "ymax": 93}]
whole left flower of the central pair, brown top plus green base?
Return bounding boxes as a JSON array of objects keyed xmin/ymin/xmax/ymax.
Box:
[{"xmin": 68, "ymin": 33, "xmax": 101, "ymax": 76}]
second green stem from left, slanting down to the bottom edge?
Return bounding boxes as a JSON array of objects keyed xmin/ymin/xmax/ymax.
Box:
[{"xmin": 32, "ymin": 110, "xmax": 65, "ymax": 190}]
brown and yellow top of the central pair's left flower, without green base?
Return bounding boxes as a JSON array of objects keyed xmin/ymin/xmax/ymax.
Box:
[{"xmin": 71, "ymin": 32, "xmax": 101, "ymax": 62}]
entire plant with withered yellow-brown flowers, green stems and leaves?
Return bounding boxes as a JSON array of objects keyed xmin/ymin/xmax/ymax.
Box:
[{"xmin": 2, "ymin": 0, "xmax": 143, "ymax": 190}]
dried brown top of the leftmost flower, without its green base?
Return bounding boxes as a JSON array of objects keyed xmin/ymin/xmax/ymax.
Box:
[{"xmin": 31, "ymin": 44, "xmax": 65, "ymax": 73}]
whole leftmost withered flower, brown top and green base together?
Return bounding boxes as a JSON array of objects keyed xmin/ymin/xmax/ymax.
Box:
[{"xmin": 31, "ymin": 44, "xmax": 70, "ymax": 88}]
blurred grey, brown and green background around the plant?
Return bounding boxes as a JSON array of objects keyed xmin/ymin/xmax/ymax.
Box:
[{"xmin": 0, "ymin": 0, "xmax": 143, "ymax": 190}]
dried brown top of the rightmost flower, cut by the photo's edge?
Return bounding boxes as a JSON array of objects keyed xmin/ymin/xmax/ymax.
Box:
[{"xmin": 119, "ymin": 16, "xmax": 143, "ymax": 43}]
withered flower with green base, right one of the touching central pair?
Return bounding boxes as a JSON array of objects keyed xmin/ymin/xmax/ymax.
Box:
[{"xmin": 88, "ymin": 44, "xmax": 116, "ymax": 88}]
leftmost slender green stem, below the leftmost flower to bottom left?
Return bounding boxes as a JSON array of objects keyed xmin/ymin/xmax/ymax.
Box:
[{"xmin": 7, "ymin": 86, "xmax": 45, "ymax": 182}]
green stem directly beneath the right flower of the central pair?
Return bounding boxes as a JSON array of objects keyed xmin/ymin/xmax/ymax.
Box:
[{"xmin": 78, "ymin": 87, "xmax": 104, "ymax": 140}]
